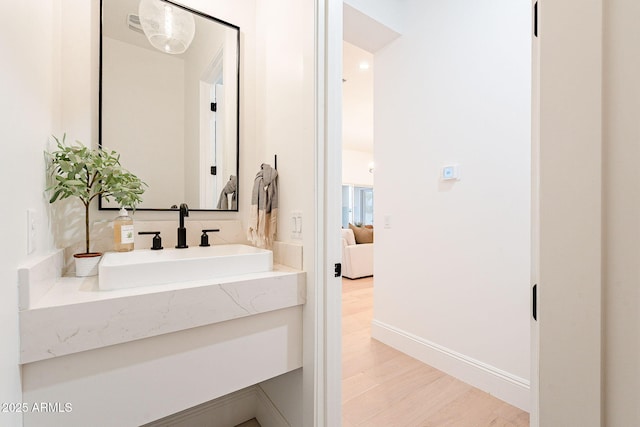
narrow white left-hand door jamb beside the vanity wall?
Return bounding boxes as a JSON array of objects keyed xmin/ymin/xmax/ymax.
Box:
[{"xmin": 313, "ymin": 0, "xmax": 343, "ymax": 427}]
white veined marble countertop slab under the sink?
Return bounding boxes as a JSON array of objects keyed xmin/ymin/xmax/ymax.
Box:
[{"xmin": 20, "ymin": 265, "xmax": 306, "ymax": 364}]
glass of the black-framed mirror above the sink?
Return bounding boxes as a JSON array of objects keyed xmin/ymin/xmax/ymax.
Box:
[{"xmin": 99, "ymin": 0, "xmax": 240, "ymax": 211}]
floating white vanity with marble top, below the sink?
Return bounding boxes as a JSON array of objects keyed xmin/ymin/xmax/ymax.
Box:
[{"xmin": 20, "ymin": 251, "xmax": 306, "ymax": 427}]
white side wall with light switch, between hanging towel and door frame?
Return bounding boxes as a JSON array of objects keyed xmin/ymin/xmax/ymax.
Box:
[{"xmin": 254, "ymin": 0, "xmax": 317, "ymax": 425}]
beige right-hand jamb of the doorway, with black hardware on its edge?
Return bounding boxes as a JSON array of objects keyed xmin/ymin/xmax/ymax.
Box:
[{"xmin": 531, "ymin": 0, "xmax": 603, "ymax": 427}]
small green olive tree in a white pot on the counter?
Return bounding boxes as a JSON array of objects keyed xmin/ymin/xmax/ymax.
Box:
[{"xmin": 46, "ymin": 135, "xmax": 146, "ymax": 276}]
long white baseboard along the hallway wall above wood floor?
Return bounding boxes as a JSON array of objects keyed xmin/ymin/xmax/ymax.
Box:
[{"xmin": 371, "ymin": 319, "xmax": 530, "ymax": 411}]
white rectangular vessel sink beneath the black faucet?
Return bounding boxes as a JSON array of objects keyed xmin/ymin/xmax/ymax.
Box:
[{"xmin": 98, "ymin": 244, "xmax": 273, "ymax": 290}]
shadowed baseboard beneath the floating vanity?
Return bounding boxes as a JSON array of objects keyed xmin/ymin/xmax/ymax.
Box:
[{"xmin": 143, "ymin": 385, "xmax": 291, "ymax": 427}]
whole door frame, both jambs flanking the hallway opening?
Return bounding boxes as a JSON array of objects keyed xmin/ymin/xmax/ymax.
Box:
[{"xmin": 314, "ymin": 0, "xmax": 603, "ymax": 427}]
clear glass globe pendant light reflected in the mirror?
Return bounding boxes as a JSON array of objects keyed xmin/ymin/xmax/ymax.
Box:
[{"xmin": 138, "ymin": 0, "xmax": 196, "ymax": 55}]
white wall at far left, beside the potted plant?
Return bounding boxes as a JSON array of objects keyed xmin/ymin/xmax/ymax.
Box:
[{"xmin": 0, "ymin": 0, "xmax": 60, "ymax": 426}]
